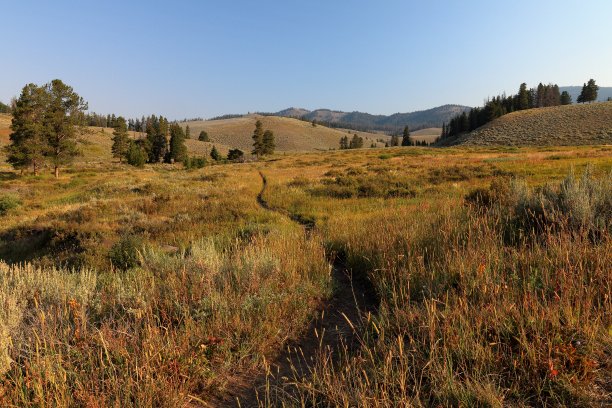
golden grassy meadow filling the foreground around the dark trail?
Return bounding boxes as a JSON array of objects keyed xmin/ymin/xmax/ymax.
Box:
[{"xmin": 0, "ymin": 139, "xmax": 612, "ymax": 407}]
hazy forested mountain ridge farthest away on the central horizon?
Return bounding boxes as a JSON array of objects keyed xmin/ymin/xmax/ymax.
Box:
[{"xmin": 274, "ymin": 105, "xmax": 471, "ymax": 131}]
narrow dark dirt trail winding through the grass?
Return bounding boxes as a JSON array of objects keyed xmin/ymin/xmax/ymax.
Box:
[{"xmin": 208, "ymin": 172, "xmax": 378, "ymax": 407}]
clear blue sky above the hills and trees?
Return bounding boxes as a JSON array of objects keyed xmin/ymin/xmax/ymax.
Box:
[{"xmin": 0, "ymin": 0, "xmax": 612, "ymax": 119}]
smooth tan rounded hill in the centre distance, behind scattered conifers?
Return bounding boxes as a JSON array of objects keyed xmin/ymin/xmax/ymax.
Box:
[{"xmin": 181, "ymin": 115, "xmax": 386, "ymax": 152}]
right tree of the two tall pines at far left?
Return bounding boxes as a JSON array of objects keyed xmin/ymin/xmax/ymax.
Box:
[{"xmin": 44, "ymin": 79, "xmax": 87, "ymax": 178}]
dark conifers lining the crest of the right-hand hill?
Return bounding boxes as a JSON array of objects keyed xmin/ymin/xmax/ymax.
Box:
[{"xmin": 441, "ymin": 79, "xmax": 599, "ymax": 139}]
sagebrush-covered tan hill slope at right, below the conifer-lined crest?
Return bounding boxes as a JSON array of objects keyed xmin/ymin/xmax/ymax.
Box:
[{"xmin": 456, "ymin": 102, "xmax": 612, "ymax": 146}]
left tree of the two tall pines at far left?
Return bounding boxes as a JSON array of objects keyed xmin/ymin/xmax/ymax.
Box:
[{"xmin": 5, "ymin": 84, "xmax": 48, "ymax": 174}]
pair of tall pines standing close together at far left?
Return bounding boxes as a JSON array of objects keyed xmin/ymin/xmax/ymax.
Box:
[{"xmin": 6, "ymin": 79, "xmax": 87, "ymax": 177}]
